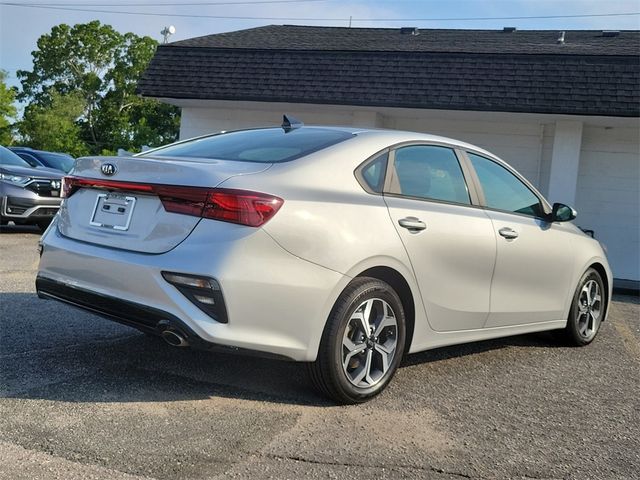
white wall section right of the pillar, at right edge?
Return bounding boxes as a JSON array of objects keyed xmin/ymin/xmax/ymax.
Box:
[{"xmin": 575, "ymin": 125, "xmax": 640, "ymax": 280}]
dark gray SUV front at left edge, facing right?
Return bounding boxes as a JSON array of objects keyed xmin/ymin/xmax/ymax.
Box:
[{"xmin": 0, "ymin": 146, "xmax": 64, "ymax": 230}]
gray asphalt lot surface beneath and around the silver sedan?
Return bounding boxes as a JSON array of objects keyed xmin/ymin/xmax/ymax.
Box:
[{"xmin": 0, "ymin": 226, "xmax": 640, "ymax": 479}]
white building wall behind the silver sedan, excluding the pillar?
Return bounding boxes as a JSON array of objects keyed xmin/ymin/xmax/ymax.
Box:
[{"xmin": 174, "ymin": 102, "xmax": 640, "ymax": 280}]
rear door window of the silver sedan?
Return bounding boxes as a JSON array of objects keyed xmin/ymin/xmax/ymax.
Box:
[{"xmin": 391, "ymin": 145, "xmax": 471, "ymax": 205}]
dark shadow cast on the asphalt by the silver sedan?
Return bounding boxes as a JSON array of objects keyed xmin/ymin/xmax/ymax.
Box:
[{"xmin": 0, "ymin": 293, "xmax": 604, "ymax": 406}]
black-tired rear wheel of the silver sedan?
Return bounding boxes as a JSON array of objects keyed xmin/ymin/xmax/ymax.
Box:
[{"xmin": 308, "ymin": 277, "xmax": 406, "ymax": 404}]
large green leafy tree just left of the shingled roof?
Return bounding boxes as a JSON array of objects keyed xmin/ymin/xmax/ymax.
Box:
[{"xmin": 18, "ymin": 21, "xmax": 179, "ymax": 153}]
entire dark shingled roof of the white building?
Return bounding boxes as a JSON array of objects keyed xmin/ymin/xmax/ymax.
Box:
[{"xmin": 138, "ymin": 25, "xmax": 640, "ymax": 117}]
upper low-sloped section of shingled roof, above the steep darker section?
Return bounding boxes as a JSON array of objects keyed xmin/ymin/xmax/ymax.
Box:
[{"xmin": 171, "ymin": 25, "xmax": 640, "ymax": 55}]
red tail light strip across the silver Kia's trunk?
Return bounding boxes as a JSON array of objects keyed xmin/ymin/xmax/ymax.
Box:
[{"xmin": 62, "ymin": 177, "xmax": 284, "ymax": 227}]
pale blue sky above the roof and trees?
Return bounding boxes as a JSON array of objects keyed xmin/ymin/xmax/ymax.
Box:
[{"xmin": 0, "ymin": 0, "xmax": 640, "ymax": 94}]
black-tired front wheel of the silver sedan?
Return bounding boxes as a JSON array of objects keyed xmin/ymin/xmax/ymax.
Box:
[{"xmin": 560, "ymin": 268, "xmax": 608, "ymax": 347}]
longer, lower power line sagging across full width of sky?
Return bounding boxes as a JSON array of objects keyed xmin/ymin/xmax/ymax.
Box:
[{"xmin": 0, "ymin": 0, "xmax": 640, "ymax": 22}]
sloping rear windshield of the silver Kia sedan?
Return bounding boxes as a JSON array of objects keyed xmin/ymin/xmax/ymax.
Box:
[{"xmin": 140, "ymin": 127, "xmax": 353, "ymax": 163}]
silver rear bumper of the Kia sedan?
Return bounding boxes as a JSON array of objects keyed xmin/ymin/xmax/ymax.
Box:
[{"xmin": 37, "ymin": 220, "xmax": 348, "ymax": 361}]
